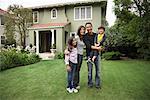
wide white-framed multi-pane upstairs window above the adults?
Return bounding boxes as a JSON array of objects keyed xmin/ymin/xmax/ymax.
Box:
[{"xmin": 74, "ymin": 6, "xmax": 92, "ymax": 20}]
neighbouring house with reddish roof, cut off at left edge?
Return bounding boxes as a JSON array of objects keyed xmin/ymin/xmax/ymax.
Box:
[{"xmin": 0, "ymin": 9, "xmax": 6, "ymax": 48}]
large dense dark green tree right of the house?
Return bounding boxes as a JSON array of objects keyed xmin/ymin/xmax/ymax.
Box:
[{"xmin": 112, "ymin": 0, "xmax": 150, "ymax": 59}]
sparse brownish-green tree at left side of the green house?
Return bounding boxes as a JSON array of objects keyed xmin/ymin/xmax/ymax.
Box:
[{"xmin": 5, "ymin": 5, "xmax": 32, "ymax": 47}]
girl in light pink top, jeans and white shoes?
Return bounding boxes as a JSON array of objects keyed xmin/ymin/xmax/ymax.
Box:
[{"xmin": 65, "ymin": 37, "xmax": 78, "ymax": 93}]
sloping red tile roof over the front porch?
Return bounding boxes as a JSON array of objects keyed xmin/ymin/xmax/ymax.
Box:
[{"xmin": 29, "ymin": 23, "xmax": 70, "ymax": 29}]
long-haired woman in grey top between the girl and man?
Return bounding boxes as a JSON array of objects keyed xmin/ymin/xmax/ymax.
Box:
[{"xmin": 74, "ymin": 26, "xmax": 85, "ymax": 89}]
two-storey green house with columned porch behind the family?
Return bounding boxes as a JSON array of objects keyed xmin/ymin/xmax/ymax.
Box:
[{"xmin": 27, "ymin": 0, "xmax": 107, "ymax": 54}]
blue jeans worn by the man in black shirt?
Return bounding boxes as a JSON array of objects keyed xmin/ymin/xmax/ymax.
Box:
[{"xmin": 87, "ymin": 55, "xmax": 100, "ymax": 87}]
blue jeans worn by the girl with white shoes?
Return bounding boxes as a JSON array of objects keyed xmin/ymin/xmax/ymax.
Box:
[{"xmin": 67, "ymin": 61, "xmax": 77, "ymax": 89}]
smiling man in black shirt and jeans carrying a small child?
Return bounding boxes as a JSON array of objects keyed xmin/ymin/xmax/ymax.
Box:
[{"xmin": 83, "ymin": 22, "xmax": 102, "ymax": 88}]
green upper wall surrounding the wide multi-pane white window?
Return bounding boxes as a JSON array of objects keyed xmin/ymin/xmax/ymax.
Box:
[{"xmin": 66, "ymin": 3, "xmax": 102, "ymax": 32}]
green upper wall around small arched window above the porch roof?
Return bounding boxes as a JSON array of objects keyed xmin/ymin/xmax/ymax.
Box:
[{"xmin": 34, "ymin": 7, "xmax": 67, "ymax": 24}]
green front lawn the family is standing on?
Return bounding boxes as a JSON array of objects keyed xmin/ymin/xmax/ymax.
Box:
[{"xmin": 0, "ymin": 60, "xmax": 150, "ymax": 100}]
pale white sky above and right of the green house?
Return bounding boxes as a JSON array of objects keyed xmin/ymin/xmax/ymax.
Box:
[{"xmin": 0, "ymin": 0, "xmax": 116, "ymax": 26}]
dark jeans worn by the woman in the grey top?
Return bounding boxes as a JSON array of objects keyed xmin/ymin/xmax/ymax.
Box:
[{"xmin": 74, "ymin": 54, "xmax": 83, "ymax": 86}]
